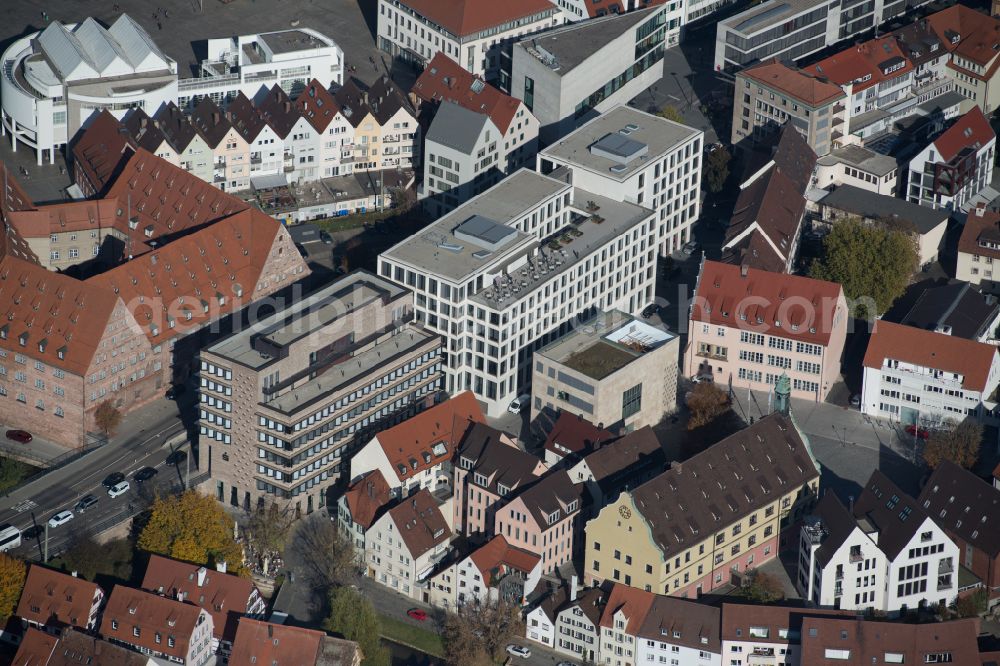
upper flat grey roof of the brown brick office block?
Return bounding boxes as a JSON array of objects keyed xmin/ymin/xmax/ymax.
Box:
[{"xmin": 208, "ymin": 271, "xmax": 406, "ymax": 370}]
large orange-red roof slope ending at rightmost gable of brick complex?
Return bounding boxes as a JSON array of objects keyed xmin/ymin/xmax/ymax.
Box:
[{"xmin": 85, "ymin": 206, "xmax": 291, "ymax": 345}]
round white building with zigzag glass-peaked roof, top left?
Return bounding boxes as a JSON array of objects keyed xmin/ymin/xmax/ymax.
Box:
[{"xmin": 0, "ymin": 14, "xmax": 178, "ymax": 164}]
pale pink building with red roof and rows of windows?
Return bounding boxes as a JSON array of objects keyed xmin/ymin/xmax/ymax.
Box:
[{"xmin": 684, "ymin": 261, "xmax": 848, "ymax": 401}]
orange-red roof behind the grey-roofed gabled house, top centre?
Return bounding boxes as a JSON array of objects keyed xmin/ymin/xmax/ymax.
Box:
[{"xmin": 410, "ymin": 51, "xmax": 521, "ymax": 134}]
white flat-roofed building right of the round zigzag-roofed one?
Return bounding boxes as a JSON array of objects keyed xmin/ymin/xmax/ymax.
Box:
[{"xmin": 176, "ymin": 28, "xmax": 344, "ymax": 109}]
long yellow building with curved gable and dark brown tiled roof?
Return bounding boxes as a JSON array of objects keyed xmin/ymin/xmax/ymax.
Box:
[{"xmin": 584, "ymin": 413, "xmax": 819, "ymax": 598}]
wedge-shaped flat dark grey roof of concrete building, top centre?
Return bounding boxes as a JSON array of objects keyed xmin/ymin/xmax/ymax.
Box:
[{"xmin": 514, "ymin": 7, "xmax": 663, "ymax": 75}]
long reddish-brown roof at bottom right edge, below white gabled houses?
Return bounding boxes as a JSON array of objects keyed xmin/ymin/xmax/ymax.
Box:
[{"xmin": 801, "ymin": 617, "xmax": 979, "ymax": 666}]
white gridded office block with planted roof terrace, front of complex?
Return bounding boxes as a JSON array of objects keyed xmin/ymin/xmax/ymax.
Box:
[{"xmin": 378, "ymin": 165, "xmax": 656, "ymax": 416}]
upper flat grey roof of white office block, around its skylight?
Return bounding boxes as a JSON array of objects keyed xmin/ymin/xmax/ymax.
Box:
[{"xmin": 382, "ymin": 169, "xmax": 568, "ymax": 283}]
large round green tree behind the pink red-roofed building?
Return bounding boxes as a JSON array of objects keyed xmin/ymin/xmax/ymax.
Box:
[{"xmin": 809, "ymin": 219, "xmax": 919, "ymax": 319}]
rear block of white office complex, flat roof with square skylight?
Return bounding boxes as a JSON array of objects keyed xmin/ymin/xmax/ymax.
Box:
[{"xmin": 538, "ymin": 106, "xmax": 704, "ymax": 255}]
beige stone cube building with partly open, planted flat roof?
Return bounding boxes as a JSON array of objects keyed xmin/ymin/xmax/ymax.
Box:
[{"xmin": 531, "ymin": 310, "xmax": 680, "ymax": 431}]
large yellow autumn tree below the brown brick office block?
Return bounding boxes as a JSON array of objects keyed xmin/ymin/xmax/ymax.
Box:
[{"xmin": 138, "ymin": 490, "xmax": 249, "ymax": 576}]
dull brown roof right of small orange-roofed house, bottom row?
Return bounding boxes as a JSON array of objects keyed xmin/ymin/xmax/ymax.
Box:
[{"xmin": 637, "ymin": 594, "xmax": 722, "ymax": 654}]
